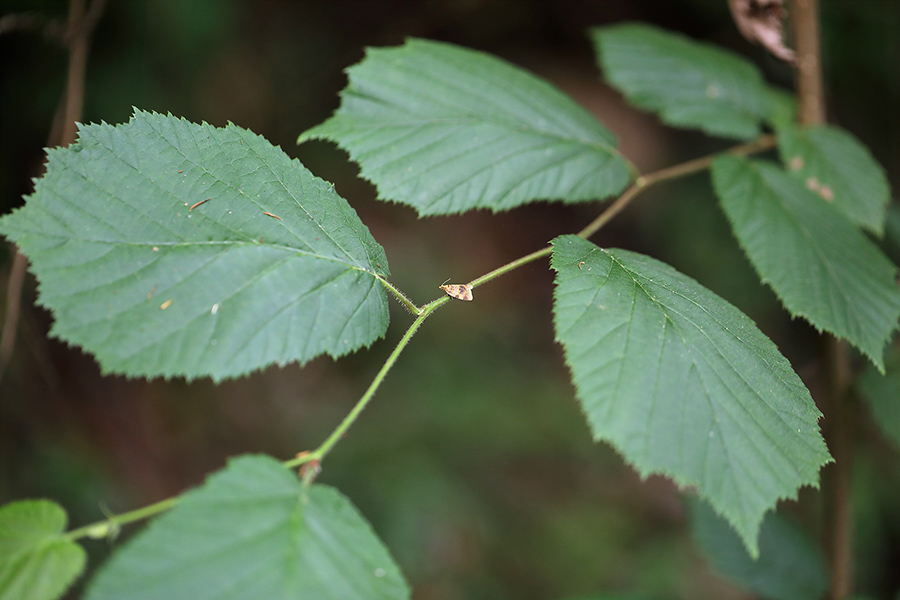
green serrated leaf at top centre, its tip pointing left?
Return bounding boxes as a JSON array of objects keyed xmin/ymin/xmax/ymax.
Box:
[{"xmin": 298, "ymin": 39, "xmax": 629, "ymax": 215}]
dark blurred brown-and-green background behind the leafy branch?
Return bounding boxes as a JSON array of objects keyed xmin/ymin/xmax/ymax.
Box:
[{"xmin": 0, "ymin": 0, "xmax": 900, "ymax": 600}]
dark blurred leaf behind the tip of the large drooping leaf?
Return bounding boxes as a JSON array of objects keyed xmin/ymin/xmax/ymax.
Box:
[{"xmin": 688, "ymin": 500, "xmax": 829, "ymax": 600}]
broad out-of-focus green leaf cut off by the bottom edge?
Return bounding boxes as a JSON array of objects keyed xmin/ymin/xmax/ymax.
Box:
[{"xmin": 87, "ymin": 456, "xmax": 410, "ymax": 600}]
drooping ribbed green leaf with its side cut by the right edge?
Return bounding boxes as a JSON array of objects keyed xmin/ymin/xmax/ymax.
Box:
[{"xmin": 712, "ymin": 156, "xmax": 900, "ymax": 372}]
